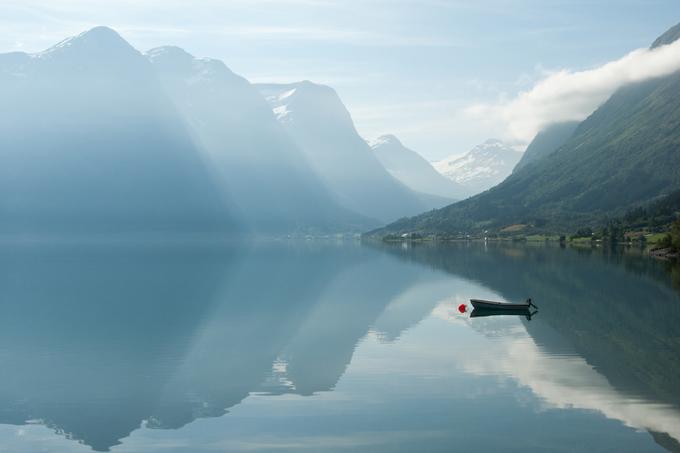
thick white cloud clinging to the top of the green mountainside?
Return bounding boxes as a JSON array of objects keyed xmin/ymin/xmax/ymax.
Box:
[{"xmin": 466, "ymin": 41, "xmax": 680, "ymax": 143}]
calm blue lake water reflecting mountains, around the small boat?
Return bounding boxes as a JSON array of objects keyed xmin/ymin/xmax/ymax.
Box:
[{"xmin": 0, "ymin": 238, "xmax": 680, "ymax": 453}]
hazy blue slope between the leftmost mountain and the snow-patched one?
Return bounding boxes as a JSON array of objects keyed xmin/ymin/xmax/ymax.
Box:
[{"xmin": 147, "ymin": 47, "xmax": 374, "ymax": 233}]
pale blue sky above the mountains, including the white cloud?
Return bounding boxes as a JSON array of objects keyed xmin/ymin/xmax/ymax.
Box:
[{"xmin": 0, "ymin": 0, "xmax": 680, "ymax": 161}]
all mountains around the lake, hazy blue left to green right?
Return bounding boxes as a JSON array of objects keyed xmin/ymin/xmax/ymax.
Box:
[{"xmin": 0, "ymin": 22, "xmax": 680, "ymax": 236}]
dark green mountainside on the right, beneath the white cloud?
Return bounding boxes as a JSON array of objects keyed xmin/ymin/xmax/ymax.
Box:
[{"xmin": 378, "ymin": 22, "xmax": 680, "ymax": 234}]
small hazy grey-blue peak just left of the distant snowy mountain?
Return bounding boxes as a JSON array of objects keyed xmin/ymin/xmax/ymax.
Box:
[{"xmin": 369, "ymin": 135, "xmax": 467, "ymax": 201}]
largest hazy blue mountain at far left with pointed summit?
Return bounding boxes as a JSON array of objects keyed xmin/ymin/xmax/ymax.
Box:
[{"xmin": 0, "ymin": 27, "xmax": 236, "ymax": 235}]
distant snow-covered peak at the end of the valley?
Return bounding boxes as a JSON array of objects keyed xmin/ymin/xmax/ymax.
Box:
[{"xmin": 434, "ymin": 139, "xmax": 522, "ymax": 195}]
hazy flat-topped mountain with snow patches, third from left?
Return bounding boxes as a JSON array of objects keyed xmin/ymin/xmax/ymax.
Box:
[{"xmin": 257, "ymin": 81, "xmax": 446, "ymax": 222}]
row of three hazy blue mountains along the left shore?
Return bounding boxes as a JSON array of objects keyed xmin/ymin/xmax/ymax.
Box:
[{"xmin": 0, "ymin": 27, "xmax": 462, "ymax": 235}]
